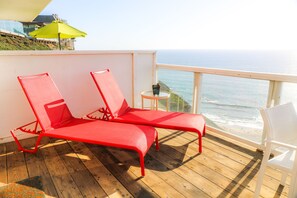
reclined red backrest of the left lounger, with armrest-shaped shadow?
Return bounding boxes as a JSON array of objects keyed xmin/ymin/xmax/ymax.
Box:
[{"xmin": 18, "ymin": 73, "xmax": 73, "ymax": 131}]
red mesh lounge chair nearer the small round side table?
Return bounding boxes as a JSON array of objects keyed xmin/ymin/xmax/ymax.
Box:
[{"xmin": 88, "ymin": 69, "xmax": 205, "ymax": 153}]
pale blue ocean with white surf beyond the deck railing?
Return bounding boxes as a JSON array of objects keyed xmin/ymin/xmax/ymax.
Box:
[{"xmin": 157, "ymin": 50, "xmax": 297, "ymax": 142}]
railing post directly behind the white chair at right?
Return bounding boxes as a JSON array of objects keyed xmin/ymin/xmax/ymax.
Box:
[{"xmin": 261, "ymin": 80, "xmax": 283, "ymax": 147}]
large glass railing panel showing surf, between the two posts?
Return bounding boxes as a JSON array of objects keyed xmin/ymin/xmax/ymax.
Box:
[{"xmin": 200, "ymin": 74, "xmax": 269, "ymax": 142}]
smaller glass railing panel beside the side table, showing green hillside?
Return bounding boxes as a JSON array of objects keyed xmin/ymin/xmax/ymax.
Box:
[{"xmin": 158, "ymin": 69, "xmax": 194, "ymax": 112}]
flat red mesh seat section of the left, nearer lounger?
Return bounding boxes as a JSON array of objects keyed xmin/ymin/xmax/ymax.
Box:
[{"xmin": 43, "ymin": 118, "xmax": 156, "ymax": 156}]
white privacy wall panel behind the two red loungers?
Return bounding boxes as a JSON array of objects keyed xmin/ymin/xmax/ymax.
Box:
[{"xmin": 0, "ymin": 51, "xmax": 155, "ymax": 143}]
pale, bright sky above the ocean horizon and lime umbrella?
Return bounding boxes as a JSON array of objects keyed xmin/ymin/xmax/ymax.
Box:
[{"xmin": 41, "ymin": 0, "xmax": 297, "ymax": 50}]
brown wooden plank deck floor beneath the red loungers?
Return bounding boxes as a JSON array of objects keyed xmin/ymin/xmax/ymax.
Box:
[{"xmin": 0, "ymin": 129, "xmax": 289, "ymax": 197}]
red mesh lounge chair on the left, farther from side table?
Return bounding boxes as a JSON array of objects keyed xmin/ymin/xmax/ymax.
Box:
[{"xmin": 11, "ymin": 73, "xmax": 159, "ymax": 176}]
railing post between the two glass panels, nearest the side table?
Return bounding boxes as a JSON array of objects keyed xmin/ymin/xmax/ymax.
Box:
[{"xmin": 192, "ymin": 72, "xmax": 202, "ymax": 114}]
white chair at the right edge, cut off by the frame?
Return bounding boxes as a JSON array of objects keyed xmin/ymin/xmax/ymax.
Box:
[{"xmin": 254, "ymin": 103, "xmax": 297, "ymax": 197}]
